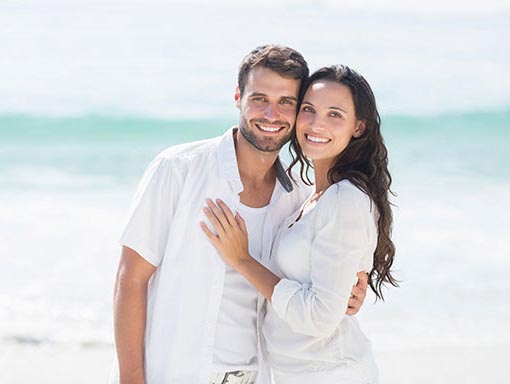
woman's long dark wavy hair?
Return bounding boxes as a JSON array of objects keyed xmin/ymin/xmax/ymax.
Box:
[{"xmin": 289, "ymin": 65, "xmax": 398, "ymax": 300}]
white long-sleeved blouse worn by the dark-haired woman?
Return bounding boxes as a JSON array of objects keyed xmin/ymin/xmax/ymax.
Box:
[{"xmin": 262, "ymin": 180, "xmax": 378, "ymax": 383}]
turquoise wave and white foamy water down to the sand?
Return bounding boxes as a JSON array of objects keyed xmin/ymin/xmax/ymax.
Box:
[{"xmin": 0, "ymin": 111, "xmax": 510, "ymax": 349}]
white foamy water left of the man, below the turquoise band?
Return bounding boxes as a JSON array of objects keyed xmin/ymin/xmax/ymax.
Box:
[{"xmin": 0, "ymin": 187, "xmax": 129, "ymax": 344}]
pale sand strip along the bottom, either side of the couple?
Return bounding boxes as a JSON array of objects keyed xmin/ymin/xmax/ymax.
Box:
[{"xmin": 0, "ymin": 344, "xmax": 510, "ymax": 384}]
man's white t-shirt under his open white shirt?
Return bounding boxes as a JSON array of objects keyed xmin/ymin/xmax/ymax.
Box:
[{"xmin": 212, "ymin": 204, "xmax": 269, "ymax": 372}]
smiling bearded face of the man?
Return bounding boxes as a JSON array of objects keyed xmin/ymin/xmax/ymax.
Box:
[{"xmin": 235, "ymin": 67, "xmax": 300, "ymax": 152}]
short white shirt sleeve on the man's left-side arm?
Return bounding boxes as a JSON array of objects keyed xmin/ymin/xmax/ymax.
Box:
[{"xmin": 119, "ymin": 157, "xmax": 179, "ymax": 266}]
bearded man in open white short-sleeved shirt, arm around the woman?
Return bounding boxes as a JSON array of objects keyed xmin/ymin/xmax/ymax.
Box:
[{"xmin": 113, "ymin": 45, "xmax": 366, "ymax": 384}]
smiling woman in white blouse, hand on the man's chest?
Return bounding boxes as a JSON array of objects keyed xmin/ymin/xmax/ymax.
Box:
[{"xmin": 202, "ymin": 65, "xmax": 397, "ymax": 384}]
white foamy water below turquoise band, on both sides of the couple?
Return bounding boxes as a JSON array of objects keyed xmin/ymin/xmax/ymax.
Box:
[{"xmin": 0, "ymin": 148, "xmax": 510, "ymax": 350}]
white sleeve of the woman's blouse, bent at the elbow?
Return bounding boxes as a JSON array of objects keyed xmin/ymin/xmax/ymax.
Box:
[{"xmin": 271, "ymin": 183, "xmax": 377, "ymax": 337}]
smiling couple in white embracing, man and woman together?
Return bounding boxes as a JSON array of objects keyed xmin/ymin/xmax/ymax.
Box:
[{"xmin": 112, "ymin": 45, "xmax": 396, "ymax": 384}]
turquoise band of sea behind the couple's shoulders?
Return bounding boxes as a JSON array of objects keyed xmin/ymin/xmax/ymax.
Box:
[{"xmin": 0, "ymin": 110, "xmax": 510, "ymax": 190}]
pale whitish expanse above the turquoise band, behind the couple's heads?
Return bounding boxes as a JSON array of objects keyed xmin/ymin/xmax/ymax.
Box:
[{"xmin": 0, "ymin": 0, "xmax": 510, "ymax": 117}]
